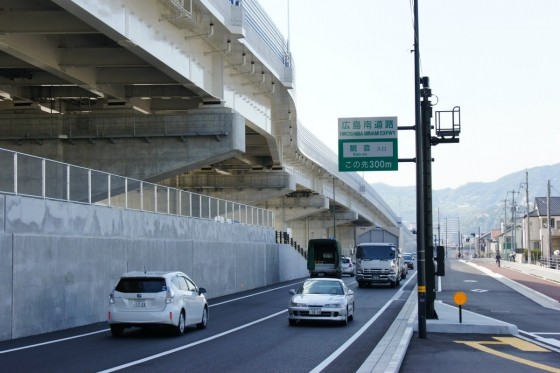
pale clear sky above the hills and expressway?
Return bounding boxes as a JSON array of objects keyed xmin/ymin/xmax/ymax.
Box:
[{"xmin": 259, "ymin": 0, "xmax": 560, "ymax": 189}]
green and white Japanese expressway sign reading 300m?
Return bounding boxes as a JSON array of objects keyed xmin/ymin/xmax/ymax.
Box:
[{"xmin": 338, "ymin": 117, "xmax": 399, "ymax": 172}]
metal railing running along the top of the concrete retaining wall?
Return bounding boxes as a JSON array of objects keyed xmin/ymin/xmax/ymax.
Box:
[{"xmin": 0, "ymin": 149, "xmax": 274, "ymax": 228}]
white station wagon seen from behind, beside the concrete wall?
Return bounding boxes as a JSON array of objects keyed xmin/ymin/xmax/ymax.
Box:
[{"xmin": 107, "ymin": 272, "xmax": 208, "ymax": 337}]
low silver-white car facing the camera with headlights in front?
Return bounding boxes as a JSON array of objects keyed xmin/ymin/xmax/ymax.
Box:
[{"xmin": 288, "ymin": 278, "xmax": 354, "ymax": 325}]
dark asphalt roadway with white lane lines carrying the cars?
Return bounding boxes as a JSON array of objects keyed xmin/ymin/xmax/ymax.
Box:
[{"xmin": 0, "ymin": 272, "xmax": 416, "ymax": 373}]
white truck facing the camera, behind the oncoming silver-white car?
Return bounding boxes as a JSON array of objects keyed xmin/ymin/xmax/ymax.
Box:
[{"xmin": 356, "ymin": 242, "xmax": 406, "ymax": 287}]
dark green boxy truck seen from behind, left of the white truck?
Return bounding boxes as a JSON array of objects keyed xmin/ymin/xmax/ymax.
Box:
[{"xmin": 307, "ymin": 238, "xmax": 342, "ymax": 278}]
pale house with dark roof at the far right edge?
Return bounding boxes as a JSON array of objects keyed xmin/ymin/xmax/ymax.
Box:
[{"xmin": 523, "ymin": 197, "xmax": 560, "ymax": 258}]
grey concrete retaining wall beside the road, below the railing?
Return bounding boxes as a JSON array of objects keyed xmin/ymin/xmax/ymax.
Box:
[{"xmin": 0, "ymin": 194, "xmax": 307, "ymax": 340}]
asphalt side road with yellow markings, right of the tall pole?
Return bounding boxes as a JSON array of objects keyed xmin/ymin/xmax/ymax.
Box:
[{"xmin": 400, "ymin": 260, "xmax": 560, "ymax": 373}]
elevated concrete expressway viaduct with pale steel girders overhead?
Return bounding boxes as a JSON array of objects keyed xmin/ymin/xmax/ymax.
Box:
[{"xmin": 0, "ymin": 0, "xmax": 414, "ymax": 250}]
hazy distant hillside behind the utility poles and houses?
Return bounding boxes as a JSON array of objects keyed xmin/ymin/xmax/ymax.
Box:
[{"xmin": 371, "ymin": 163, "xmax": 560, "ymax": 235}]
